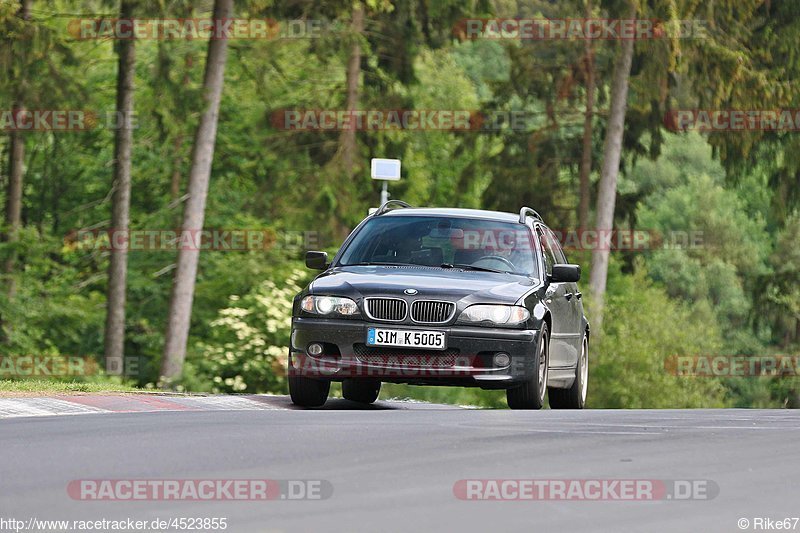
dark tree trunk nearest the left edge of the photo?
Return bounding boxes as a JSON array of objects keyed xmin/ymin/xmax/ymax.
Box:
[{"xmin": 3, "ymin": 0, "xmax": 33, "ymax": 300}]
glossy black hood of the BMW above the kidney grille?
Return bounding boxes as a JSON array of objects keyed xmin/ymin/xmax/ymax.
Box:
[{"xmin": 309, "ymin": 266, "xmax": 539, "ymax": 303}]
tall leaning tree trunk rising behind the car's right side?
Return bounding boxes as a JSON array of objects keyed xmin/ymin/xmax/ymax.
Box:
[{"xmin": 589, "ymin": 6, "xmax": 636, "ymax": 334}]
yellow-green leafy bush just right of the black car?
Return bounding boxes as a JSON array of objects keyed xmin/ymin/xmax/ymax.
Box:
[{"xmin": 587, "ymin": 265, "xmax": 726, "ymax": 409}]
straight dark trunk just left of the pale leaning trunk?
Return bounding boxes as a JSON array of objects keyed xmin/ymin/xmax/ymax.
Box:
[{"xmin": 105, "ymin": 0, "xmax": 136, "ymax": 375}]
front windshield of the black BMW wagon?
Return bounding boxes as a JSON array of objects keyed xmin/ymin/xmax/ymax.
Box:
[{"xmin": 338, "ymin": 216, "xmax": 539, "ymax": 278}]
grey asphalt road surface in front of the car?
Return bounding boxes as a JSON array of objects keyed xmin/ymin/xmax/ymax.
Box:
[{"xmin": 0, "ymin": 400, "xmax": 800, "ymax": 532}]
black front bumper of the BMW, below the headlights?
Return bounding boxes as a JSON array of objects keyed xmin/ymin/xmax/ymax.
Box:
[{"xmin": 289, "ymin": 317, "xmax": 539, "ymax": 389}]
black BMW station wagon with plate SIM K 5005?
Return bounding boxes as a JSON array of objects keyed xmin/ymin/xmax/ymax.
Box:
[{"xmin": 288, "ymin": 201, "xmax": 589, "ymax": 408}]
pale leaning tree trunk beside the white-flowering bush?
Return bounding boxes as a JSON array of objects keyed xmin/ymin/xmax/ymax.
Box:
[{"xmin": 161, "ymin": 0, "xmax": 233, "ymax": 386}]
